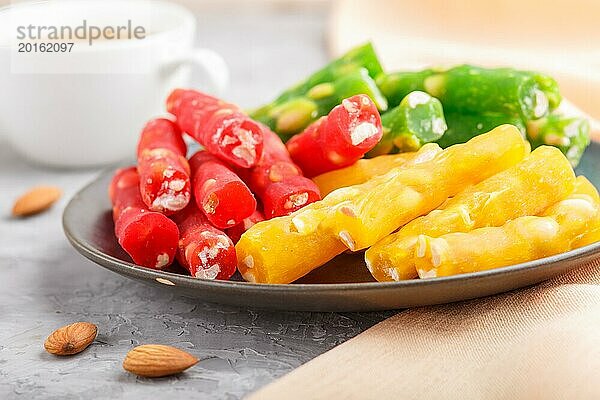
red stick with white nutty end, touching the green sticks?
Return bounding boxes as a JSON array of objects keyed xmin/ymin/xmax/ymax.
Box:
[{"xmin": 286, "ymin": 94, "xmax": 383, "ymax": 177}]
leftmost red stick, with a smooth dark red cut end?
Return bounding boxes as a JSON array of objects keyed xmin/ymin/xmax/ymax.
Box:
[{"xmin": 108, "ymin": 167, "xmax": 179, "ymax": 269}]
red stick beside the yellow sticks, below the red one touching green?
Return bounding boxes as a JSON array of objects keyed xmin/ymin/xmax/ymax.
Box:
[{"xmin": 240, "ymin": 126, "xmax": 321, "ymax": 219}]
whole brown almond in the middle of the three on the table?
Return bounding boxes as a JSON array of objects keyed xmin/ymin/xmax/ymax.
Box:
[{"xmin": 44, "ymin": 322, "xmax": 98, "ymax": 356}]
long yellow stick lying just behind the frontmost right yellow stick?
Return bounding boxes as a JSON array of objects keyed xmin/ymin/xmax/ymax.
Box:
[{"xmin": 365, "ymin": 146, "xmax": 575, "ymax": 281}]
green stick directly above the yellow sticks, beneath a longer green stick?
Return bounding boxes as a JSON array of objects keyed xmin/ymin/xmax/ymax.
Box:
[{"xmin": 437, "ymin": 112, "xmax": 525, "ymax": 149}]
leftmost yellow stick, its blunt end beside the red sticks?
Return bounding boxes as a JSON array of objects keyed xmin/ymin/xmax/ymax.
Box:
[{"xmin": 236, "ymin": 142, "xmax": 440, "ymax": 283}]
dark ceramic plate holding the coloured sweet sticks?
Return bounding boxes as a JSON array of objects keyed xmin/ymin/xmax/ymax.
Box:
[{"xmin": 63, "ymin": 144, "xmax": 600, "ymax": 311}]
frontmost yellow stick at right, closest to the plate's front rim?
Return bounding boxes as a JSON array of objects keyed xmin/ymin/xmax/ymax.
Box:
[{"xmin": 415, "ymin": 177, "xmax": 600, "ymax": 278}]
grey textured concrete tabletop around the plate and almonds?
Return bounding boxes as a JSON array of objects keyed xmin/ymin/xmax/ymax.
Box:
[{"xmin": 0, "ymin": 3, "xmax": 391, "ymax": 399}]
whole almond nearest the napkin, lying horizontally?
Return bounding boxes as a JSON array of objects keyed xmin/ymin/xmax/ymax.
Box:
[{"xmin": 123, "ymin": 344, "xmax": 198, "ymax": 378}]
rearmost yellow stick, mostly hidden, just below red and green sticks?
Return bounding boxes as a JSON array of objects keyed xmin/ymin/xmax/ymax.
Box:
[{"xmin": 313, "ymin": 143, "xmax": 442, "ymax": 197}]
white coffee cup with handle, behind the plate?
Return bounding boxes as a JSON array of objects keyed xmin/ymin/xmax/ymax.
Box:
[{"xmin": 0, "ymin": 0, "xmax": 228, "ymax": 167}]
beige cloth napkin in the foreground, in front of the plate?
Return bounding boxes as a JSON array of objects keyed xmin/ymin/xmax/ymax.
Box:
[{"xmin": 249, "ymin": 259, "xmax": 600, "ymax": 400}]
